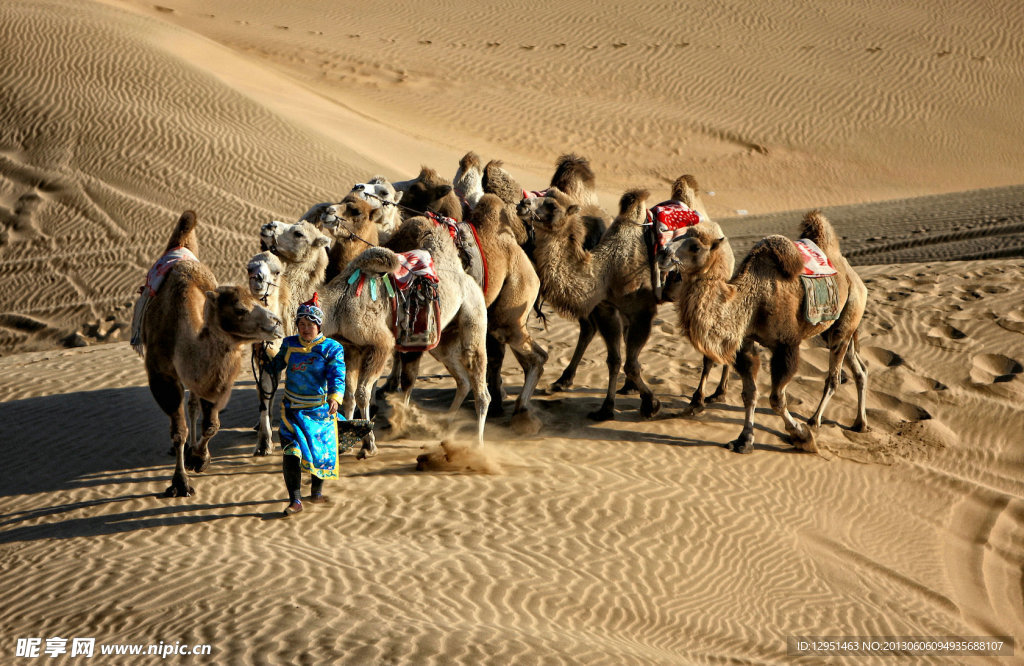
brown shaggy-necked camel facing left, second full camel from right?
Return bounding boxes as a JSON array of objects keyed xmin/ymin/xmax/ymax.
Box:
[{"xmin": 518, "ymin": 188, "xmax": 660, "ymax": 420}]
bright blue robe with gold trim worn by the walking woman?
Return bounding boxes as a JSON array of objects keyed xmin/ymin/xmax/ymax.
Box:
[{"xmin": 273, "ymin": 335, "xmax": 345, "ymax": 478}]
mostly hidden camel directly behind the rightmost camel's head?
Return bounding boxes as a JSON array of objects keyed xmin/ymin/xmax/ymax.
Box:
[{"xmin": 655, "ymin": 174, "xmax": 736, "ymax": 415}]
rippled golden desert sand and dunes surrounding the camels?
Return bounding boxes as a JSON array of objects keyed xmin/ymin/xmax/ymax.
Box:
[{"xmin": 0, "ymin": 0, "xmax": 1024, "ymax": 664}]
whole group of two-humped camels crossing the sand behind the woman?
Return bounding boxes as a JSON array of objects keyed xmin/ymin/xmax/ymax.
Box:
[{"xmin": 125, "ymin": 153, "xmax": 867, "ymax": 496}]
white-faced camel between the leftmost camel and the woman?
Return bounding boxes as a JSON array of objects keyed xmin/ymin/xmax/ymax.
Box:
[{"xmin": 246, "ymin": 252, "xmax": 295, "ymax": 456}]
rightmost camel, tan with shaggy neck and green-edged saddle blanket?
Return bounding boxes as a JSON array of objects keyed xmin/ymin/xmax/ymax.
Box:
[{"xmin": 676, "ymin": 211, "xmax": 867, "ymax": 453}]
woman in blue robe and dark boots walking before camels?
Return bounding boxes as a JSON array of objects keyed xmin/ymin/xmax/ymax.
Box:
[{"xmin": 272, "ymin": 294, "xmax": 345, "ymax": 515}]
